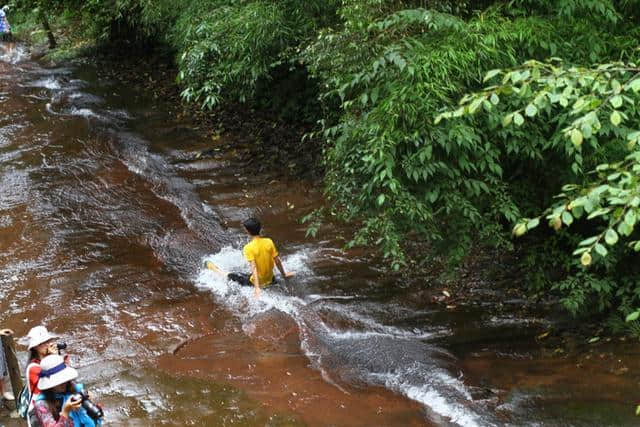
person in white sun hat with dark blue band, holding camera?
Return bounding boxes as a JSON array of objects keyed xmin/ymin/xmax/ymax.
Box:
[{"xmin": 29, "ymin": 354, "xmax": 82, "ymax": 427}]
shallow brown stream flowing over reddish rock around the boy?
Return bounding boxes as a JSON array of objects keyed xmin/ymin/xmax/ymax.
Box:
[{"xmin": 0, "ymin": 46, "xmax": 640, "ymax": 426}]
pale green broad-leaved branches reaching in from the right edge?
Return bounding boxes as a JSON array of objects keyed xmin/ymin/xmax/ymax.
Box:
[{"xmin": 436, "ymin": 56, "xmax": 640, "ymax": 314}]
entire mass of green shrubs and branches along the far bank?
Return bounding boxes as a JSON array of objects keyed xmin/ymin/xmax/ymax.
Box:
[{"xmin": 8, "ymin": 0, "xmax": 640, "ymax": 329}]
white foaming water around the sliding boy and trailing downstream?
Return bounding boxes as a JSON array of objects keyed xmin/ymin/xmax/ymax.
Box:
[{"xmin": 196, "ymin": 246, "xmax": 493, "ymax": 427}]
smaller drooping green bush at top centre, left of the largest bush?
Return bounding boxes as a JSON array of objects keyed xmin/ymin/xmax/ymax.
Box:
[{"xmin": 173, "ymin": 0, "xmax": 332, "ymax": 108}]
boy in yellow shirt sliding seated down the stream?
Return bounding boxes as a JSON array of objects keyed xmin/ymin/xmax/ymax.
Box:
[{"xmin": 205, "ymin": 218, "xmax": 295, "ymax": 298}]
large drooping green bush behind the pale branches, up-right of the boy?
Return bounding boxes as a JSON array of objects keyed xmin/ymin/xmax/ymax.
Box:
[{"xmin": 303, "ymin": 1, "xmax": 630, "ymax": 267}]
